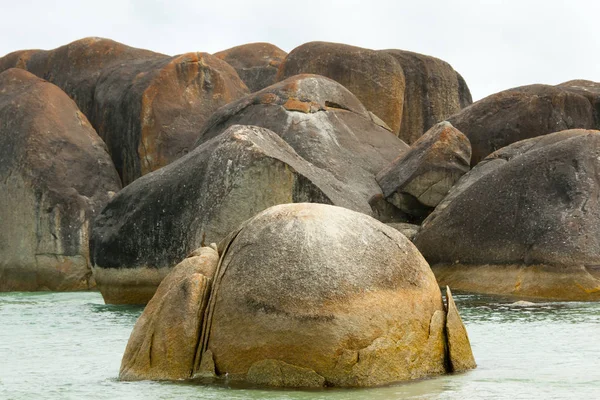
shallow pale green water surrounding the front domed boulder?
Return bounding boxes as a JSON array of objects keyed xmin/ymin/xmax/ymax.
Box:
[{"xmin": 0, "ymin": 292, "xmax": 600, "ymax": 400}]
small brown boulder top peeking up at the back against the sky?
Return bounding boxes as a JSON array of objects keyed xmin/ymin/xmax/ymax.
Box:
[{"xmin": 214, "ymin": 43, "xmax": 287, "ymax": 92}]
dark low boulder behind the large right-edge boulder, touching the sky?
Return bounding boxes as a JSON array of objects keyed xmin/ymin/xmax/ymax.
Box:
[{"xmin": 448, "ymin": 81, "xmax": 600, "ymax": 165}]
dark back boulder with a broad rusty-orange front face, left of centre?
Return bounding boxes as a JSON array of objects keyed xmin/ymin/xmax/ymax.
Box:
[{"xmin": 92, "ymin": 49, "xmax": 248, "ymax": 185}]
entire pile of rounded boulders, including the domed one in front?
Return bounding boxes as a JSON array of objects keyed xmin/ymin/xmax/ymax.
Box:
[{"xmin": 0, "ymin": 38, "xmax": 600, "ymax": 387}]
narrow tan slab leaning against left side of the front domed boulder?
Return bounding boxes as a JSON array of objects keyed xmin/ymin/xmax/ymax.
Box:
[{"xmin": 119, "ymin": 247, "xmax": 219, "ymax": 381}]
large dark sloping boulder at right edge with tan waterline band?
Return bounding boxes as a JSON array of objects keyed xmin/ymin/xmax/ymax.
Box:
[{"xmin": 415, "ymin": 130, "xmax": 600, "ymax": 301}]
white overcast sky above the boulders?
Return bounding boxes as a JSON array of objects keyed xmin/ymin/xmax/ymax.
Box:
[{"xmin": 0, "ymin": 0, "xmax": 600, "ymax": 100}]
